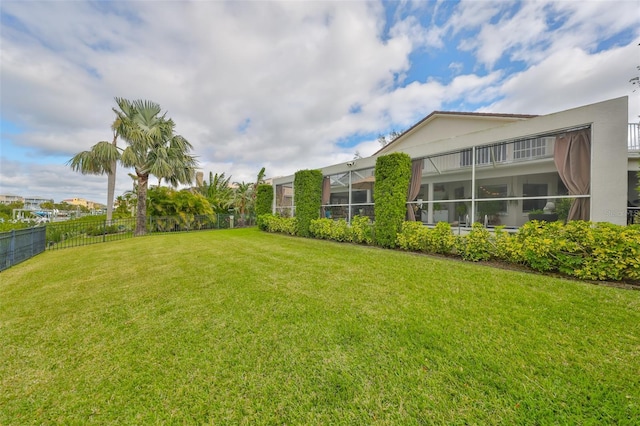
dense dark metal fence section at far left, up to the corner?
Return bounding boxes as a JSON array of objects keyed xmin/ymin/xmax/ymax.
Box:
[{"xmin": 0, "ymin": 226, "xmax": 46, "ymax": 271}]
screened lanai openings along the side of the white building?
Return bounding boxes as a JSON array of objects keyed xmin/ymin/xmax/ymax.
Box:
[{"xmin": 276, "ymin": 128, "xmax": 590, "ymax": 227}]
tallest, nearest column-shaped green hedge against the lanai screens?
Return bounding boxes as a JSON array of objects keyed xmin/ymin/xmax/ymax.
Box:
[{"xmin": 374, "ymin": 152, "xmax": 411, "ymax": 247}]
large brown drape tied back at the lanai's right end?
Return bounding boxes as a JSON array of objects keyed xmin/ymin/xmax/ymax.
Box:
[{"xmin": 553, "ymin": 129, "xmax": 591, "ymax": 220}]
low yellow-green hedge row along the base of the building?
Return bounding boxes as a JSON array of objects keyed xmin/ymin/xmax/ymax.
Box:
[{"xmin": 259, "ymin": 215, "xmax": 640, "ymax": 282}]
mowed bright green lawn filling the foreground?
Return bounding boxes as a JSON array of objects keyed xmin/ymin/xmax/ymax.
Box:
[{"xmin": 0, "ymin": 229, "xmax": 640, "ymax": 425}]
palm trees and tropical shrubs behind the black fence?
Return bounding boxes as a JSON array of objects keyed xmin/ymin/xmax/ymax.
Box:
[{"xmin": 67, "ymin": 98, "xmax": 265, "ymax": 235}]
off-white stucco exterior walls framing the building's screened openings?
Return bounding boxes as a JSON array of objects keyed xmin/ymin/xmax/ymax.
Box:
[{"xmin": 274, "ymin": 97, "xmax": 632, "ymax": 225}]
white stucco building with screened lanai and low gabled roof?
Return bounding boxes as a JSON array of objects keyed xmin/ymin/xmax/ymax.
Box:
[{"xmin": 273, "ymin": 97, "xmax": 640, "ymax": 227}]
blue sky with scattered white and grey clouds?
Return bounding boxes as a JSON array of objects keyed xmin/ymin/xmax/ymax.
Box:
[{"xmin": 0, "ymin": 0, "xmax": 640, "ymax": 203}]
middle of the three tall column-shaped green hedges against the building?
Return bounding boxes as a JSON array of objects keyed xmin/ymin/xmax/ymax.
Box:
[{"xmin": 293, "ymin": 170, "xmax": 323, "ymax": 237}]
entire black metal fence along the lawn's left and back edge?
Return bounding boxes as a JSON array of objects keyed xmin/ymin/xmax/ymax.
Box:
[{"xmin": 0, "ymin": 214, "xmax": 255, "ymax": 271}]
